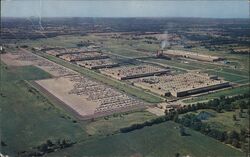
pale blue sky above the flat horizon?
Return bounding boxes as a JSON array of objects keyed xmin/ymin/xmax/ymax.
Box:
[{"xmin": 1, "ymin": 0, "xmax": 250, "ymax": 18}]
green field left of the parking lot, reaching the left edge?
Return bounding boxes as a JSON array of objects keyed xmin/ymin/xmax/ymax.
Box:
[{"xmin": 0, "ymin": 65, "xmax": 87, "ymax": 156}]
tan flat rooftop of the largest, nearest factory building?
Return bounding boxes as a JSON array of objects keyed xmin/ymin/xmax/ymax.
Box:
[{"xmin": 132, "ymin": 72, "xmax": 228, "ymax": 96}]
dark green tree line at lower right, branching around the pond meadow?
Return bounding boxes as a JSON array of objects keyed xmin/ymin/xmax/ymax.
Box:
[{"xmin": 120, "ymin": 93, "xmax": 250, "ymax": 151}]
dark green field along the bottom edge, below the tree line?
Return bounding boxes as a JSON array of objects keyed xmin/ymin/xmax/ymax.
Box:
[{"xmin": 47, "ymin": 121, "xmax": 244, "ymax": 157}]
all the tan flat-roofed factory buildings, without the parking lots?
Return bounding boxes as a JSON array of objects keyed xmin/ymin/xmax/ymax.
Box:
[{"xmin": 43, "ymin": 48, "xmax": 230, "ymax": 97}]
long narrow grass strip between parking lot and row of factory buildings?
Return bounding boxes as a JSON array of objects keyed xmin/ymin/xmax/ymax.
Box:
[{"xmin": 35, "ymin": 53, "xmax": 163, "ymax": 103}]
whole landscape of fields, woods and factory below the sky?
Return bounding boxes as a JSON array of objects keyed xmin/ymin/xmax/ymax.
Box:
[{"xmin": 0, "ymin": 0, "xmax": 250, "ymax": 157}]
